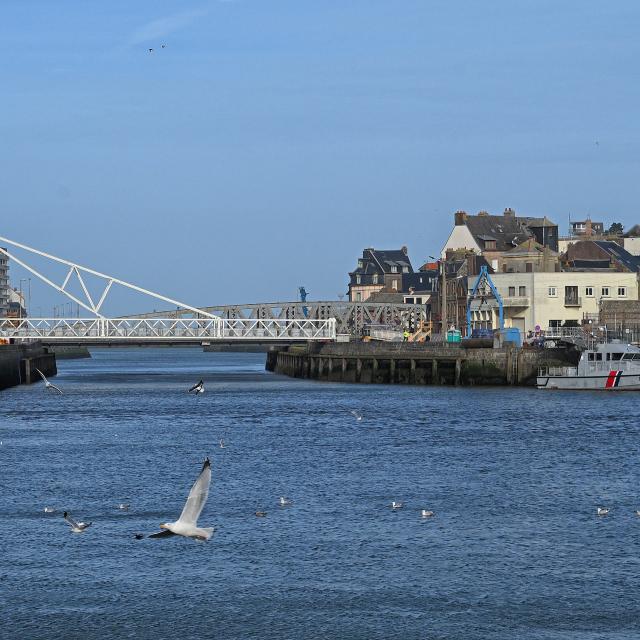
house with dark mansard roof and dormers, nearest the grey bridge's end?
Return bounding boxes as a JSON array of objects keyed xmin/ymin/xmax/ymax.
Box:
[{"xmin": 349, "ymin": 247, "xmax": 414, "ymax": 302}]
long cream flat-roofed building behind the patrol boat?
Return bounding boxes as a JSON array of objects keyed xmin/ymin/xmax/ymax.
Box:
[{"xmin": 468, "ymin": 270, "xmax": 638, "ymax": 333}]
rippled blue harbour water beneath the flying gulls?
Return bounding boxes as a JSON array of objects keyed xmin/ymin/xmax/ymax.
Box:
[{"xmin": 0, "ymin": 349, "xmax": 640, "ymax": 640}]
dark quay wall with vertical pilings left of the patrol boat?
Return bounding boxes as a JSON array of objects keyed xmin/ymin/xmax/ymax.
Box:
[{"xmin": 266, "ymin": 341, "xmax": 577, "ymax": 385}]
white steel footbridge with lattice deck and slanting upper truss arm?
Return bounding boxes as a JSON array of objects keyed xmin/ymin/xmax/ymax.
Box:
[{"xmin": 0, "ymin": 236, "xmax": 336, "ymax": 344}]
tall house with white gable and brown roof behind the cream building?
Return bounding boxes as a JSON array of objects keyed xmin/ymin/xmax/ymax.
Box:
[{"xmin": 441, "ymin": 208, "xmax": 558, "ymax": 271}]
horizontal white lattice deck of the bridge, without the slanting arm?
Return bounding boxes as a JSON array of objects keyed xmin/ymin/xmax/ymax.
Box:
[{"xmin": 0, "ymin": 318, "xmax": 336, "ymax": 343}]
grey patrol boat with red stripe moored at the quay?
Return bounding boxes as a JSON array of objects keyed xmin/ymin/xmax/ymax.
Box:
[{"xmin": 537, "ymin": 340, "xmax": 640, "ymax": 391}]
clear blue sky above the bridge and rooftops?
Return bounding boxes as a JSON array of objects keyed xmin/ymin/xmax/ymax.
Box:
[{"xmin": 0, "ymin": 0, "xmax": 640, "ymax": 312}]
